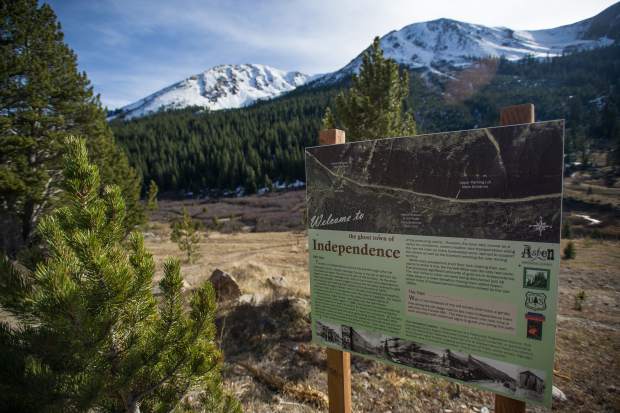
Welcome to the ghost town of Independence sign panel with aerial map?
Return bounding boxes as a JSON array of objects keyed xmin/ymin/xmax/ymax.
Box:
[{"xmin": 306, "ymin": 121, "xmax": 564, "ymax": 406}]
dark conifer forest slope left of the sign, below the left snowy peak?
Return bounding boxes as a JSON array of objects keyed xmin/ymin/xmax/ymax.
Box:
[{"xmin": 112, "ymin": 88, "xmax": 335, "ymax": 192}]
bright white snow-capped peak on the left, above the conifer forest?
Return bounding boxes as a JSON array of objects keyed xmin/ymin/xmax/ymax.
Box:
[{"xmin": 109, "ymin": 64, "xmax": 310, "ymax": 119}]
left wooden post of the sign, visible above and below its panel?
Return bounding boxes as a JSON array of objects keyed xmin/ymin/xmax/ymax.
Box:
[{"xmin": 319, "ymin": 129, "xmax": 351, "ymax": 413}]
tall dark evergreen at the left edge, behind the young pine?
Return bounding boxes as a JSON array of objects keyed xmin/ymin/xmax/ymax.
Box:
[{"xmin": 0, "ymin": 0, "xmax": 142, "ymax": 256}]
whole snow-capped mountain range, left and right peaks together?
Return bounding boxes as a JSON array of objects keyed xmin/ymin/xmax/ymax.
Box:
[{"xmin": 109, "ymin": 2, "xmax": 620, "ymax": 119}]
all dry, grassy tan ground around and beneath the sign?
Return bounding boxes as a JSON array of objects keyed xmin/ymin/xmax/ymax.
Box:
[{"xmin": 145, "ymin": 216, "xmax": 620, "ymax": 413}]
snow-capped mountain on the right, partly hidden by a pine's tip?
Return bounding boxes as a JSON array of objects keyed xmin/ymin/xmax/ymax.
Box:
[{"xmin": 315, "ymin": 3, "xmax": 620, "ymax": 84}]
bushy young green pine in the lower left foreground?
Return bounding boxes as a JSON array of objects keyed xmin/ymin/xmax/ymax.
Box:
[{"xmin": 0, "ymin": 138, "xmax": 238, "ymax": 413}]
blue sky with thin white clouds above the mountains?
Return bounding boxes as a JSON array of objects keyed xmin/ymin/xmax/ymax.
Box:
[{"xmin": 46, "ymin": 0, "xmax": 615, "ymax": 108}]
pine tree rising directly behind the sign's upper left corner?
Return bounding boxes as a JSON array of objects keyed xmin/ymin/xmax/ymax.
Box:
[{"xmin": 336, "ymin": 37, "xmax": 416, "ymax": 141}]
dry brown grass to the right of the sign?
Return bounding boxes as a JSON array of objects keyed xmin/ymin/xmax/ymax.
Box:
[{"xmin": 534, "ymin": 238, "xmax": 620, "ymax": 413}]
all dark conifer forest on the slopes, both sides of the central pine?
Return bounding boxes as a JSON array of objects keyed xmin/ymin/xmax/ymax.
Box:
[{"xmin": 112, "ymin": 46, "xmax": 620, "ymax": 194}]
